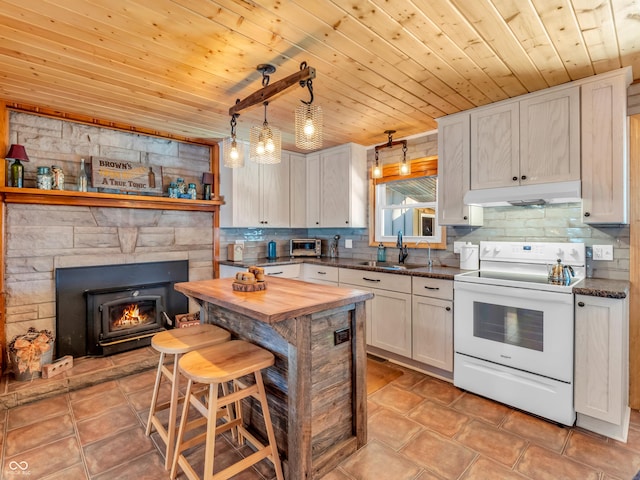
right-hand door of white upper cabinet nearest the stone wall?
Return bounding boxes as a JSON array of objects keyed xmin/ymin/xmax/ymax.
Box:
[{"xmin": 260, "ymin": 153, "xmax": 289, "ymax": 228}]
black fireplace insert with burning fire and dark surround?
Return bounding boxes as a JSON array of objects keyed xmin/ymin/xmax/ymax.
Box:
[{"xmin": 55, "ymin": 261, "xmax": 189, "ymax": 357}]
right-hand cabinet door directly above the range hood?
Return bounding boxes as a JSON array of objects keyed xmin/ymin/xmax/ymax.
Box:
[{"xmin": 520, "ymin": 87, "xmax": 580, "ymax": 185}]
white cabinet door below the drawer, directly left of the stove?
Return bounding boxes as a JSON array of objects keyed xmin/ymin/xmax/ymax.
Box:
[{"xmin": 412, "ymin": 295, "xmax": 453, "ymax": 372}]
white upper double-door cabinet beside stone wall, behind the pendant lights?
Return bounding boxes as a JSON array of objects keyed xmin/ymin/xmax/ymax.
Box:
[{"xmin": 220, "ymin": 145, "xmax": 290, "ymax": 228}]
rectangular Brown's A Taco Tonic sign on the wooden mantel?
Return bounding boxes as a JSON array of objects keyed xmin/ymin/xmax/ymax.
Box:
[{"xmin": 91, "ymin": 157, "xmax": 163, "ymax": 195}]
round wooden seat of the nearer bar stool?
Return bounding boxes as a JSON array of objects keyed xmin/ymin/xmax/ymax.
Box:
[{"xmin": 179, "ymin": 340, "xmax": 275, "ymax": 383}]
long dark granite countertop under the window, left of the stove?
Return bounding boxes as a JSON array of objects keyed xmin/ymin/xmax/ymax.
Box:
[{"xmin": 220, "ymin": 257, "xmax": 468, "ymax": 280}]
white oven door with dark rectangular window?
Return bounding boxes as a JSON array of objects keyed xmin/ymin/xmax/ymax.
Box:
[{"xmin": 454, "ymin": 281, "xmax": 574, "ymax": 383}]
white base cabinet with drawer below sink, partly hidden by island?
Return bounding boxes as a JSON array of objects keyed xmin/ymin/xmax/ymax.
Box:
[{"xmin": 339, "ymin": 268, "xmax": 411, "ymax": 358}]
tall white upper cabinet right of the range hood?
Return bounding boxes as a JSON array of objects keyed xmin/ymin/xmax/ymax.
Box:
[{"xmin": 581, "ymin": 68, "xmax": 631, "ymax": 224}]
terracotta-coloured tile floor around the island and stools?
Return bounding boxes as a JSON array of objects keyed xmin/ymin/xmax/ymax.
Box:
[{"xmin": 0, "ymin": 354, "xmax": 640, "ymax": 480}]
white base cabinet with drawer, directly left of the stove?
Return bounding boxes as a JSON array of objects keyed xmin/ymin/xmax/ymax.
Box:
[{"xmin": 412, "ymin": 277, "xmax": 453, "ymax": 372}]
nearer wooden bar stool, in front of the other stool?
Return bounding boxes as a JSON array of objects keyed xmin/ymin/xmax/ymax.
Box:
[{"xmin": 170, "ymin": 340, "xmax": 284, "ymax": 480}]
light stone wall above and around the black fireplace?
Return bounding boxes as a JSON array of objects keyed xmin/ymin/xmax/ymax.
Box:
[{"xmin": 4, "ymin": 112, "xmax": 213, "ymax": 341}]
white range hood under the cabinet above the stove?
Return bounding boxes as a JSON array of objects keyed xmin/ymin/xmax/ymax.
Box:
[{"xmin": 464, "ymin": 180, "xmax": 581, "ymax": 207}]
